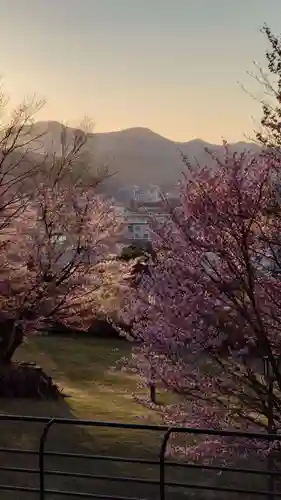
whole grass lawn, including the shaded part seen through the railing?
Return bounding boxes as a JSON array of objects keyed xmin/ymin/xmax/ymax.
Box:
[{"xmin": 0, "ymin": 337, "xmax": 189, "ymax": 500}]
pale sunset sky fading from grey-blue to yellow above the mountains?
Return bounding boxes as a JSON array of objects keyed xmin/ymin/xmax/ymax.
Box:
[{"xmin": 0, "ymin": 0, "xmax": 281, "ymax": 143}]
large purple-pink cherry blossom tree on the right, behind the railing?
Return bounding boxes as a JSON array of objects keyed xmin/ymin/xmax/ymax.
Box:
[{"xmin": 123, "ymin": 145, "xmax": 281, "ymax": 458}]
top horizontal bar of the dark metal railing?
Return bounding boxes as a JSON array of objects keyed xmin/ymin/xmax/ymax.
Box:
[{"xmin": 0, "ymin": 414, "xmax": 281, "ymax": 441}]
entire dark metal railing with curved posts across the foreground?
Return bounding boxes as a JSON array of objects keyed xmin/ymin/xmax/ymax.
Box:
[{"xmin": 0, "ymin": 415, "xmax": 281, "ymax": 500}]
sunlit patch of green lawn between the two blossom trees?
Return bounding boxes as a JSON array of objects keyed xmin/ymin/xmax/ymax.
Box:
[{"xmin": 18, "ymin": 337, "xmax": 167, "ymax": 455}]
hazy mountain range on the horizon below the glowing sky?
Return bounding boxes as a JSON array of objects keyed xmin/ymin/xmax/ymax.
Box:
[{"xmin": 26, "ymin": 122, "xmax": 259, "ymax": 197}]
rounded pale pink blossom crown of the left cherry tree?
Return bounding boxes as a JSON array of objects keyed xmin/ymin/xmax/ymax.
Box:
[{"xmin": 0, "ymin": 191, "xmax": 122, "ymax": 359}]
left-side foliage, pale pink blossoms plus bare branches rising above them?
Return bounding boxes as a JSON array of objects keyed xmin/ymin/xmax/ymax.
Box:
[{"xmin": 0, "ymin": 90, "xmax": 129, "ymax": 362}]
